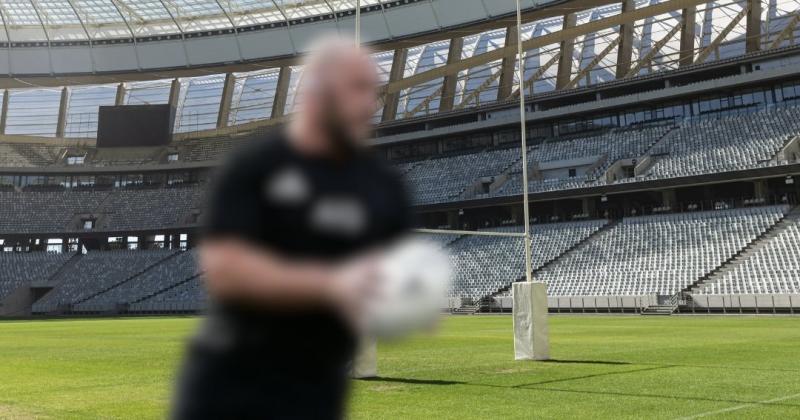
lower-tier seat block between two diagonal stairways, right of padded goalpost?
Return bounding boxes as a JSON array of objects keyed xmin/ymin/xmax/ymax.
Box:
[{"xmin": 537, "ymin": 206, "xmax": 788, "ymax": 296}]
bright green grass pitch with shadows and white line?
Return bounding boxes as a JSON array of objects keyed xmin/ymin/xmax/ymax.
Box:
[{"xmin": 0, "ymin": 316, "xmax": 800, "ymax": 419}]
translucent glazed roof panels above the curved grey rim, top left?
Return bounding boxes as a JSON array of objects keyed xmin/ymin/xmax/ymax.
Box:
[{"xmin": 0, "ymin": 0, "xmax": 390, "ymax": 42}]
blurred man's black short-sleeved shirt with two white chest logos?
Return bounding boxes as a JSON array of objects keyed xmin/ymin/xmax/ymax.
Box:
[{"xmin": 200, "ymin": 131, "xmax": 409, "ymax": 370}]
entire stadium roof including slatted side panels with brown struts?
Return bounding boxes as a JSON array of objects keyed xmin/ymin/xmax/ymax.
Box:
[{"xmin": 0, "ymin": 0, "xmax": 800, "ymax": 137}]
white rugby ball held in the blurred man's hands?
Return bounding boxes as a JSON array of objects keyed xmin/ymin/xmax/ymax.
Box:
[{"xmin": 366, "ymin": 238, "xmax": 452, "ymax": 338}]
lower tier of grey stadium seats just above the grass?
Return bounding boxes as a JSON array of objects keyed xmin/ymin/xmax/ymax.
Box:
[{"xmin": 0, "ymin": 206, "xmax": 800, "ymax": 313}]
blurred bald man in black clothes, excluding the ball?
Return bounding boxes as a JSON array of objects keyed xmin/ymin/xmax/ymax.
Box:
[{"xmin": 173, "ymin": 40, "xmax": 408, "ymax": 420}]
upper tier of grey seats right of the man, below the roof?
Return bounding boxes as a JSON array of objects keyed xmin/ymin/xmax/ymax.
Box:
[{"xmin": 398, "ymin": 105, "xmax": 800, "ymax": 204}]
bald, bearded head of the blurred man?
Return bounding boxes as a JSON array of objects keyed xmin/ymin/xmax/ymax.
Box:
[{"xmin": 296, "ymin": 37, "xmax": 378, "ymax": 153}]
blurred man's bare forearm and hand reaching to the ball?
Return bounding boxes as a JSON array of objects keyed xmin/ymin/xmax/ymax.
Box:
[{"xmin": 200, "ymin": 239, "xmax": 375, "ymax": 313}]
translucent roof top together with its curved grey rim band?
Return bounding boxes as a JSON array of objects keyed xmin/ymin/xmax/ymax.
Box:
[{"xmin": 0, "ymin": 0, "xmax": 576, "ymax": 77}]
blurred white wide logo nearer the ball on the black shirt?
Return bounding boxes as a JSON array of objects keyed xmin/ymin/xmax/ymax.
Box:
[{"xmin": 310, "ymin": 196, "xmax": 367, "ymax": 236}]
